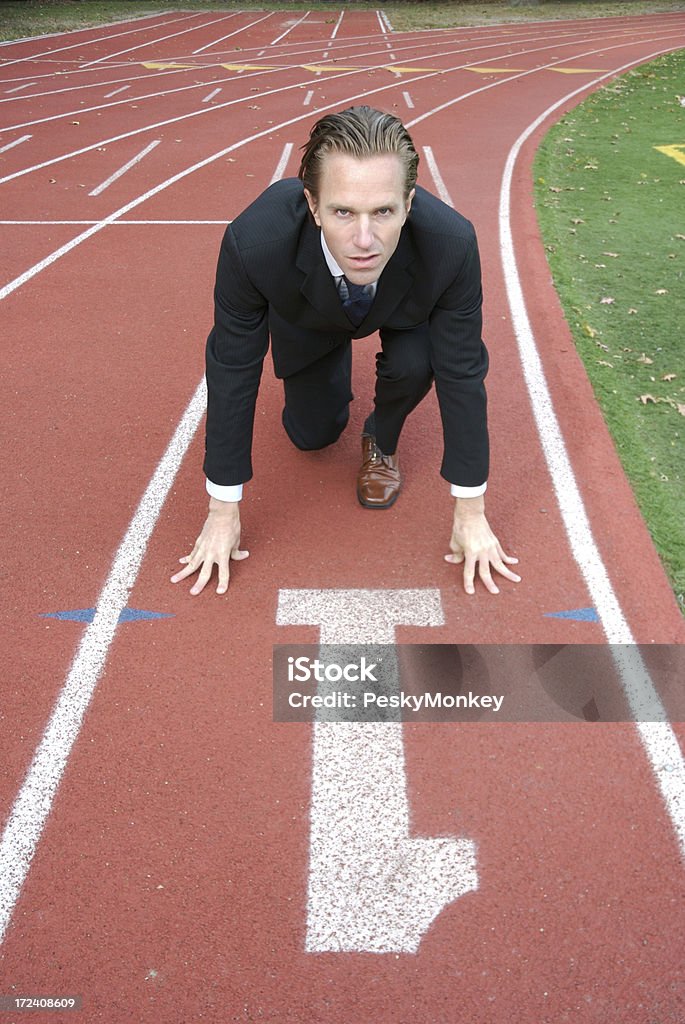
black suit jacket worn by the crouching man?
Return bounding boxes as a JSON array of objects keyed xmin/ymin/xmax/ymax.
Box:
[{"xmin": 204, "ymin": 178, "xmax": 488, "ymax": 486}]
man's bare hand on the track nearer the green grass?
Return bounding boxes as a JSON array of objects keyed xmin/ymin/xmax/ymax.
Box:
[{"xmin": 444, "ymin": 497, "xmax": 521, "ymax": 594}]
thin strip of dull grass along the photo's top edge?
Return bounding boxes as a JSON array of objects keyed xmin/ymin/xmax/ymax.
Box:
[{"xmin": 0, "ymin": 0, "xmax": 685, "ymax": 39}]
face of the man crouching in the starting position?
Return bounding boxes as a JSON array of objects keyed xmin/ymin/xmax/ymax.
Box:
[{"xmin": 304, "ymin": 153, "xmax": 414, "ymax": 285}]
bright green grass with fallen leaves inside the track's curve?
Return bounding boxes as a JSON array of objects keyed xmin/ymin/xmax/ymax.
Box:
[{"xmin": 533, "ymin": 51, "xmax": 685, "ymax": 607}]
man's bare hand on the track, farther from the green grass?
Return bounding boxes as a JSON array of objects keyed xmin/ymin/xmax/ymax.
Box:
[{"xmin": 171, "ymin": 498, "xmax": 250, "ymax": 595}]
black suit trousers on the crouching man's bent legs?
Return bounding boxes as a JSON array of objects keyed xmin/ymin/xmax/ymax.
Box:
[{"xmin": 283, "ymin": 324, "xmax": 433, "ymax": 455}]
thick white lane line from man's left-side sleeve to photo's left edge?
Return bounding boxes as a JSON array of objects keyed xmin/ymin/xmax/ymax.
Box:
[{"xmin": 0, "ymin": 381, "xmax": 206, "ymax": 942}]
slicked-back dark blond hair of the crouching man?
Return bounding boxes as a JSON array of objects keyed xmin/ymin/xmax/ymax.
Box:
[{"xmin": 298, "ymin": 106, "xmax": 419, "ymax": 199}]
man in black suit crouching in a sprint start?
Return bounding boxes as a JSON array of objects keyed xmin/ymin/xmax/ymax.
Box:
[{"xmin": 171, "ymin": 106, "xmax": 519, "ymax": 594}]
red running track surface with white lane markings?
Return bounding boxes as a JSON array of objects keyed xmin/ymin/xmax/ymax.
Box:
[{"xmin": 0, "ymin": 10, "xmax": 685, "ymax": 1024}]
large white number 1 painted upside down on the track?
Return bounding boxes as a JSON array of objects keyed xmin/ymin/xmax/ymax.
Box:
[{"xmin": 276, "ymin": 590, "xmax": 478, "ymax": 953}]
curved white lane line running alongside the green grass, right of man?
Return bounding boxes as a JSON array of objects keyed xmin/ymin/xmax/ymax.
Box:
[{"xmin": 493, "ymin": 49, "xmax": 685, "ymax": 857}]
